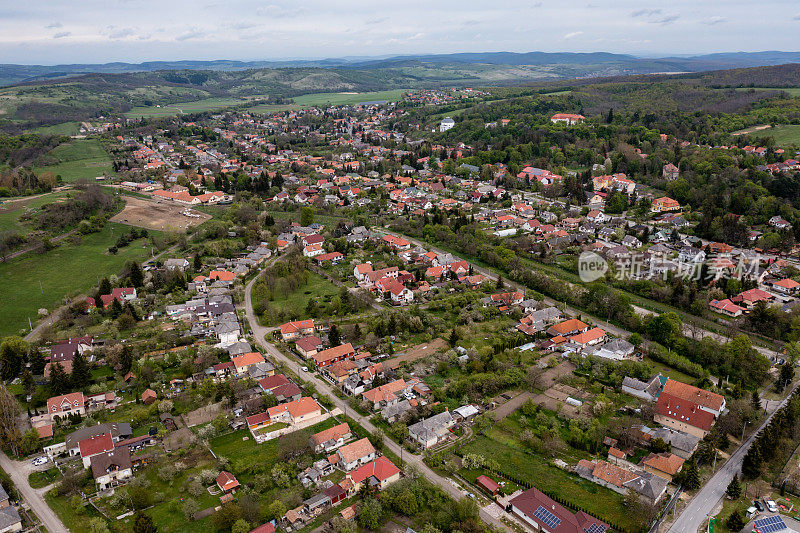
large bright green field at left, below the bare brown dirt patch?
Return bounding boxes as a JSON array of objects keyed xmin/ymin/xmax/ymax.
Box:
[{"xmin": 0, "ymin": 223, "xmax": 156, "ymax": 337}]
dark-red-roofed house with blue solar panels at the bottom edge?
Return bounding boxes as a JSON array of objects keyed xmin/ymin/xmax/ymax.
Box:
[{"xmin": 508, "ymin": 488, "xmax": 608, "ymax": 533}]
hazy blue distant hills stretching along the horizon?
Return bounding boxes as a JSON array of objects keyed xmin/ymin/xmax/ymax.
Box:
[{"xmin": 0, "ymin": 51, "xmax": 800, "ymax": 86}]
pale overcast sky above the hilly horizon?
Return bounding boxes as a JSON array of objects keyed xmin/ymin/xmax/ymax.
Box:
[{"xmin": 0, "ymin": 0, "xmax": 800, "ymax": 64}]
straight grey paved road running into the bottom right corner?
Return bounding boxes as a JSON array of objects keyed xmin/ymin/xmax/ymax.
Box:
[{"xmin": 668, "ymin": 385, "xmax": 797, "ymax": 533}]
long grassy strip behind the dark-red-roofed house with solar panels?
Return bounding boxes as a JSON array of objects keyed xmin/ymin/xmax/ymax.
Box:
[{"xmin": 462, "ymin": 436, "xmax": 641, "ymax": 531}]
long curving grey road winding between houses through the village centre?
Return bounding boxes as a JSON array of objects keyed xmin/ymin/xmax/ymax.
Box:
[{"xmin": 244, "ymin": 276, "xmax": 511, "ymax": 531}]
